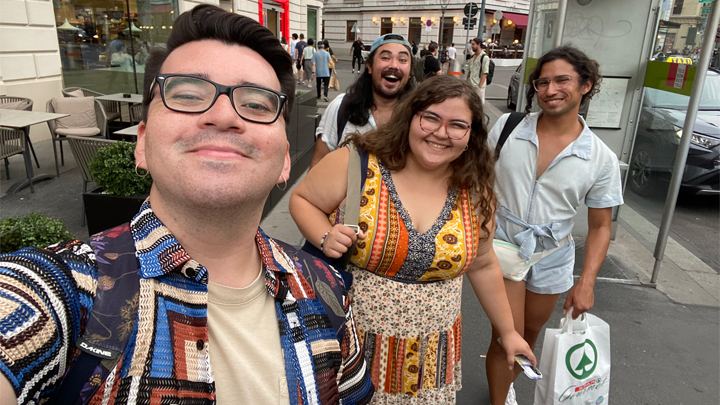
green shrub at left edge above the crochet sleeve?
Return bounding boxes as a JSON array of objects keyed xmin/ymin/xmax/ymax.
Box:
[{"xmin": 0, "ymin": 212, "xmax": 75, "ymax": 253}]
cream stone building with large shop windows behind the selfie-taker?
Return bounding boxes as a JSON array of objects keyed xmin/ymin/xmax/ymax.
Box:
[{"xmin": 0, "ymin": 0, "xmax": 323, "ymax": 139}]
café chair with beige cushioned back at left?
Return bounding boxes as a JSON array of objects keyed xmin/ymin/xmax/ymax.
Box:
[{"xmin": 46, "ymin": 97, "xmax": 107, "ymax": 177}]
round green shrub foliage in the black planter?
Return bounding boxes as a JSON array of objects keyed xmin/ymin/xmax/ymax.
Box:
[{"xmin": 89, "ymin": 141, "xmax": 152, "ymax": 196}]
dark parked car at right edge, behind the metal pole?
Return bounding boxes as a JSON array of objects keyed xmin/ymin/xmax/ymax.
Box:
[{"xmin": 628, "ymin": 69, "xmax": 720, "ymax": 195}]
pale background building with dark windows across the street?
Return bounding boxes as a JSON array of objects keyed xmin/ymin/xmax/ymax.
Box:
[{"xmin": 323, "ymin": 0, "xmax": 530, "ymax": 52}]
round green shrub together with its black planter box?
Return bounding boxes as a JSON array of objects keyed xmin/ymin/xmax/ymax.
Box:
[{"xmin": 83, "ymin": 141, "xmax": 152, "ymax": 235}]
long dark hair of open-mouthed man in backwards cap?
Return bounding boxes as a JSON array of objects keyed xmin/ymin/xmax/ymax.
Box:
[{"xmin": 343, "ymin": 47, "xmax": 417, "ymax": 126}]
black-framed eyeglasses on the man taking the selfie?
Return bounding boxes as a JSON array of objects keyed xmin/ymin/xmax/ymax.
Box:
[{"xmin": 150, "ymin": 74, "xmax": 287, "ymax": 124}]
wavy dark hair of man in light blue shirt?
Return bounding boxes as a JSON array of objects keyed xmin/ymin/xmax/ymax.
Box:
[{"xmin": 525, "ymin": 45, "xmax": 602, "ymax": 113}]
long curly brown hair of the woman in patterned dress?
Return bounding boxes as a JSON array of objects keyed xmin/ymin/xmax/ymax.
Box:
[{"xmin": 345, "ymin": 75, "xmax": 495, "ymax": 240}]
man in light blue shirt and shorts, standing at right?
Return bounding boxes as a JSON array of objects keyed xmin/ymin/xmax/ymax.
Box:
[{"xmin": 486, "ymin": 46, "xmax": 623, "ymax": 404}]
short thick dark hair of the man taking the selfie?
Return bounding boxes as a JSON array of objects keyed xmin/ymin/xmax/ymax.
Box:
[{"xmin": 143, "ymin": 4, "xmax": 295, "ymax": 123}]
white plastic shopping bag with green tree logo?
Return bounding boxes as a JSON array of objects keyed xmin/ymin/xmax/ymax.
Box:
[{"xmin": 535, "ymin": 308, "xmax": 610, "ymax": 405}]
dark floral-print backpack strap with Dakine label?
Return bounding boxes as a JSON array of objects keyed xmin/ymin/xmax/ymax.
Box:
[{"xmin": 50, "ymin": 224, "xmax": 140, "ymax": 404}]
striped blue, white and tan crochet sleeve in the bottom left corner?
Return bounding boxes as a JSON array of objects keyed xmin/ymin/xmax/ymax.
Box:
[{"xmin": 0, "ymin": 241, "xmax": 97, "ymax": 404}]
